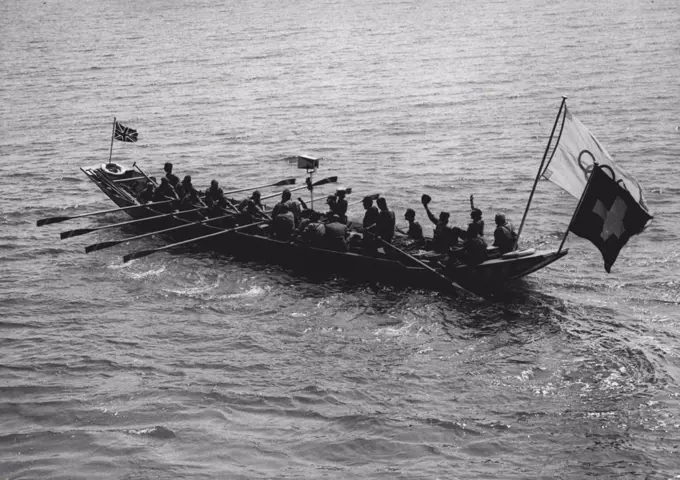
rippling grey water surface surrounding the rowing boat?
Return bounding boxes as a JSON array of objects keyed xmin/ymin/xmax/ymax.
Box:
[{"xmin": 0, "ymin": 0, "xmax": 680, "ymax": 479}]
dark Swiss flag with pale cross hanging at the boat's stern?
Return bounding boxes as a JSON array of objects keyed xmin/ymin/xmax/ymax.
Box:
[{"xmin": 569, "ymin": 164, "xmax": 653, "ymax": 273}]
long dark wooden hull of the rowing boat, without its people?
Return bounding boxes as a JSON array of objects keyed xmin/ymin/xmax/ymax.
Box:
[{"xmin": 66, "ymin": 164, "xmax": 568, "ymax": 294}]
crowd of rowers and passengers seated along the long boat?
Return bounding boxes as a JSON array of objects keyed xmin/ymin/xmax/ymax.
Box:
[{"xmin": 131, "ymin": 162, "xmax": 517, "ymax": 266}]
